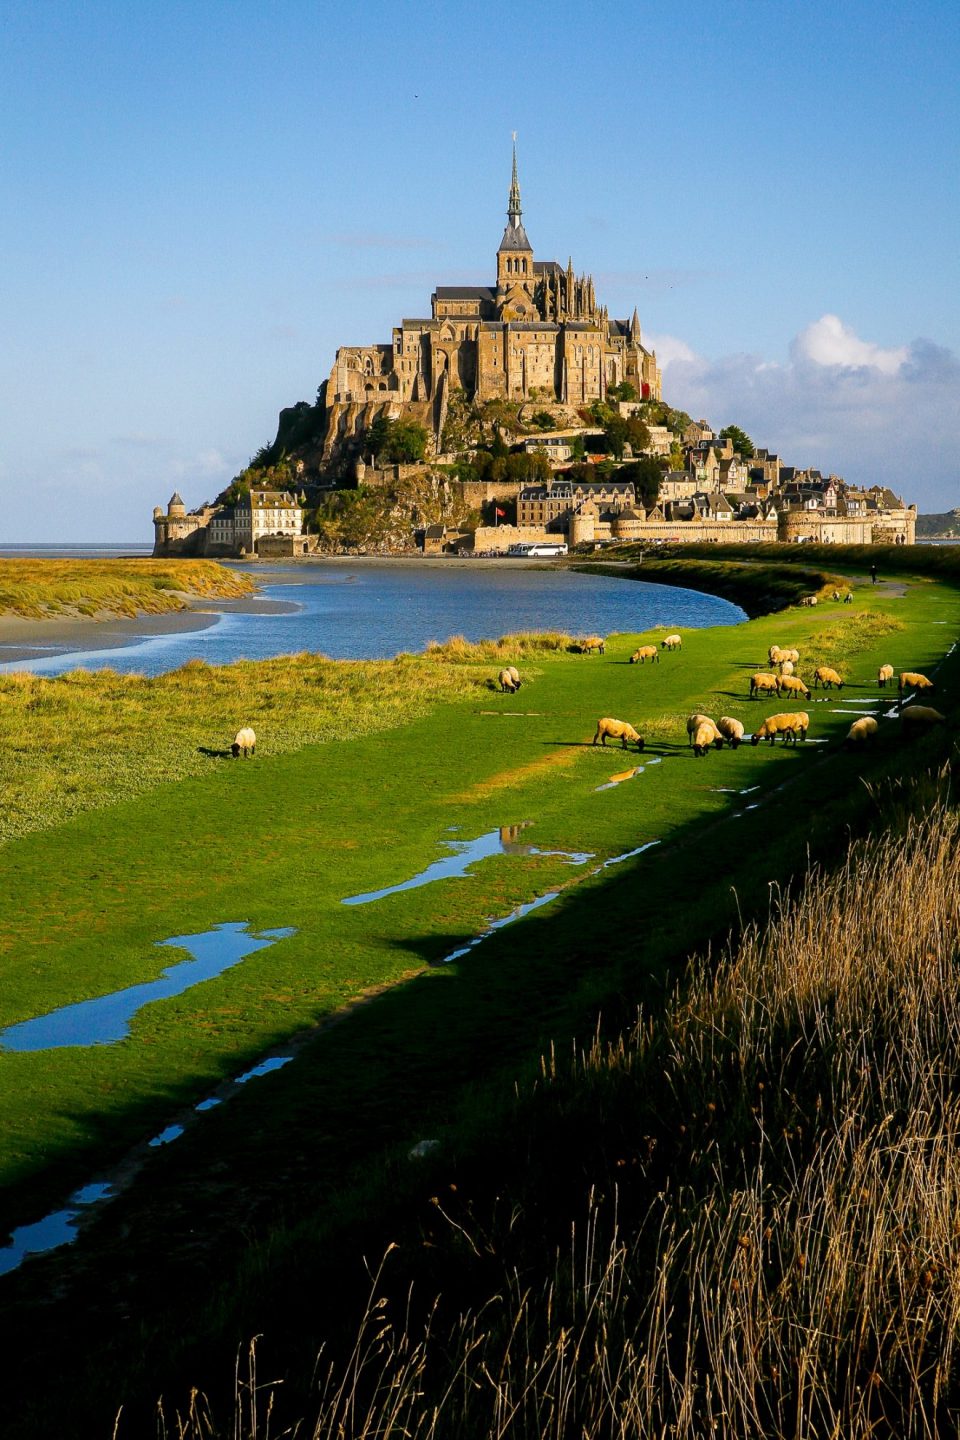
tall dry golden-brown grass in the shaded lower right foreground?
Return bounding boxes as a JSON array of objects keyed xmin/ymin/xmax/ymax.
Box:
[{"xmin": 151, "ymin": 801, "xmax": 960, "ymax": 1440}]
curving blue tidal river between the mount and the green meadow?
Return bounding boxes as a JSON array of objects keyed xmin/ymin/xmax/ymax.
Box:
[{"xmin": 0, "ymin": 559, "xmax": 746, "ymax": 675}]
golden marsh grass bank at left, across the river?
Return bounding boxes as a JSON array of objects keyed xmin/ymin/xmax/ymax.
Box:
[{"xmin": 0, "ymin": 559, "xmax": 255, "ymax": 619}]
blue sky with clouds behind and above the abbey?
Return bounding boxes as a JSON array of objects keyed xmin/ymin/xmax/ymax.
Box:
[{"xmin": 0, "ymin": 0, "xmax": 960, "ymax": 543}]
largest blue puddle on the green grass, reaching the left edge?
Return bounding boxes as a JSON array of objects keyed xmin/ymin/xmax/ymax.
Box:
[{"xmin": 0, "ymin": 920, "xmax": 295, "ymax": 1051}]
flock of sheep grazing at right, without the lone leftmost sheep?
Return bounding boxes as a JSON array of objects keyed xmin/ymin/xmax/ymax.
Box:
[{"xmin": 498, "ymin": 610, "xmax": 946, "ymax": 757}]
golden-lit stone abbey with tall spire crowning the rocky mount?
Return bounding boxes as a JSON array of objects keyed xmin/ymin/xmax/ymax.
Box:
[{"xmin": 327, "ymin": 147, "xmax": 661, "ymax": 433}]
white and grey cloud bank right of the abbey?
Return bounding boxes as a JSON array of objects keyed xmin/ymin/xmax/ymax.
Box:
[{"xmin": 651, "ymin": 315, "xmax": 960, "ymax": 510}]
